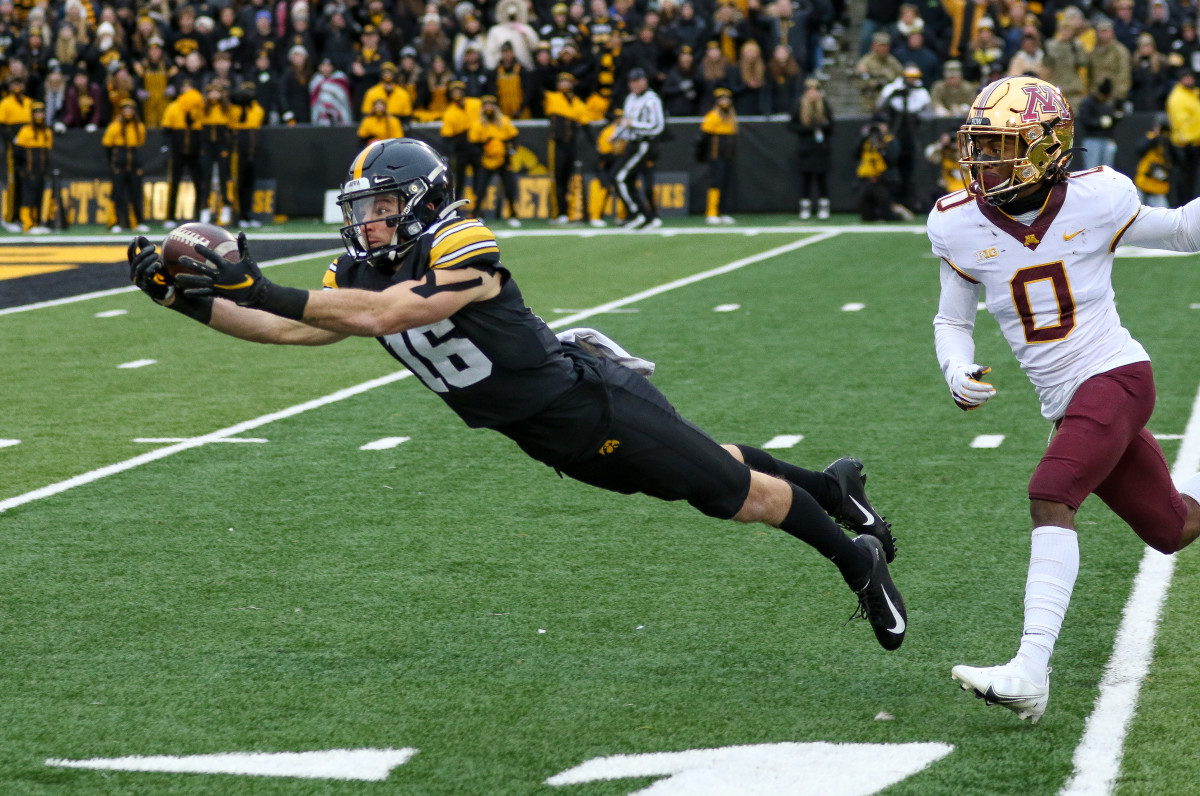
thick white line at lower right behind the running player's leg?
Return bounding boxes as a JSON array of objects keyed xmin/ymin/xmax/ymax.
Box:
[{"xmin": 1058, "ymin": 379, "xmax": 1200, "ymax": 796}]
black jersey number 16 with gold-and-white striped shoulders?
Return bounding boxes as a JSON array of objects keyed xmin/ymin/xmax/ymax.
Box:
[{"xmin": 324, "ymin": 216, "xmax": 577, "ymax": 427}]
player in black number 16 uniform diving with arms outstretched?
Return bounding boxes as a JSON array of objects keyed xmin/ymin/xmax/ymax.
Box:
[{"xmin": 128, "ymin": 138, "xmax": 907, "ymax": 650}]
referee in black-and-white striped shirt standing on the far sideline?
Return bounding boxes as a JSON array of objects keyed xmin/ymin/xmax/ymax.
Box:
[{"xmin": 614, "ymin": 67, "xmax": 666, "ymax": 229}]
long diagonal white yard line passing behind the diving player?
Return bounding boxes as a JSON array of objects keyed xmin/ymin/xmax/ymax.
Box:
[{"xmin": 0, "ymin": 232, "xmax": 838, "ymax": 514}]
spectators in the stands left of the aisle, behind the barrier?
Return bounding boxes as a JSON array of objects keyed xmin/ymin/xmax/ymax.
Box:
[{"xmin": 0, "ymin": 0, "xmax": 846, "ymax": 132}]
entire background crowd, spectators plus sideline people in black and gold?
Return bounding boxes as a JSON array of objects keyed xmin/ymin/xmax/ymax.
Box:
[{"xmin": 0, "ymin": 0, "xmax": 1200, "ymax": 231}]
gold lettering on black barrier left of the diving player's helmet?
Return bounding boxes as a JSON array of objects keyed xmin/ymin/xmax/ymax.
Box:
[{"xmin": 55, "ymin": 179, "xmax": 276, "ymax": 226}]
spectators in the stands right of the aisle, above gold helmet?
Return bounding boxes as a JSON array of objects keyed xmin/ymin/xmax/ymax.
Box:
[{"xmin": 854, "ymin": 0, "xmax": 1200, "ymax": 116}]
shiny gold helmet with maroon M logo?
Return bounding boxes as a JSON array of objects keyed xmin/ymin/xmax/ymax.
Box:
[{"xmin": 959, "ymin": 77, "xmax": 1075, "ymax": 204}]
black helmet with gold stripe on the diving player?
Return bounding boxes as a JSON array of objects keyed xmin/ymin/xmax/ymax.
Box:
[{"xmin": 337, "ymin": 138, "xmax": 466, "ymax": 268}]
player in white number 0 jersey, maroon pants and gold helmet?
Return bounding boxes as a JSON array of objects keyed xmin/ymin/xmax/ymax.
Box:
[{"xmin": 928, "ymin": 77, "xmax": 1200, "ymax": 723}]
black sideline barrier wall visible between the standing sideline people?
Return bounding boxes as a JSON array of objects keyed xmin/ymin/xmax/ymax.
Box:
[{"xmin": 25, "ymin": 113, "xmax": 1156, "ymax": 223}]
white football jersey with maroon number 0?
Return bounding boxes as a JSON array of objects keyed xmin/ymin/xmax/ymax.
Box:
[{"xmin": 926, "ymin": 167, "xmax": 1150, "ymax": 420}]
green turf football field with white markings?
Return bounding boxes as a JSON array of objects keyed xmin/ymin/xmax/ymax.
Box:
[{"xmin": 0, "ymin": 219, "xmax": 1200, "ymax": 796}]
